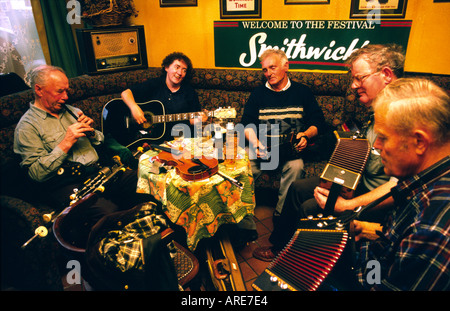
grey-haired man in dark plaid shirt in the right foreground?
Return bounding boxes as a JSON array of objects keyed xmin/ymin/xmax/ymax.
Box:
[{"xmin": 357, "ymin": 79, "xmax": 450, "ymax": 290}]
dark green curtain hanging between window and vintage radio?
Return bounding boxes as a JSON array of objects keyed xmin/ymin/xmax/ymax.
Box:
[{"xmin": 40, "ymin": 0, "xmax": 82, "ymax": 78}]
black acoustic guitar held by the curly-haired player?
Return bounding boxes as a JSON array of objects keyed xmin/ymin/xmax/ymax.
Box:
[{"xmin": 102, "ymin": 99, "xmax": 236, "ymax": 147}]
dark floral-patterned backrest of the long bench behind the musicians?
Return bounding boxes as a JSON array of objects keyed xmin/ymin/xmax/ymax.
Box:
[{"xmin": 0, "ymin": 67, "xmax": 450, "ymax": 187}]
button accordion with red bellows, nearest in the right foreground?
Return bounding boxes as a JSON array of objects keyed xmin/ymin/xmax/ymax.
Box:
[{"xmin": 252, "ymin": 216, "xmax": 351, "ymax": 291}]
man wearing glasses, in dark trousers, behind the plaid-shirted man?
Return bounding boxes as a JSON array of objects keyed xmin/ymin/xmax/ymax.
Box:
[{"xmin": 253, "ymin": 44, "xmax": 405, "ymax": 261}]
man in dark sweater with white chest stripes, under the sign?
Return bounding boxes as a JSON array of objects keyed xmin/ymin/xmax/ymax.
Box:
[{"xmin": 241, "ymin": 49, "xmax": 325, "ymax": 236}]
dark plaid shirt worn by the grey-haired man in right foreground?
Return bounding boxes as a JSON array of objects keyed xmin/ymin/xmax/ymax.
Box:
[{"xmin": 357, "ymin": 157, "xmax": 450, "ymax": 290}]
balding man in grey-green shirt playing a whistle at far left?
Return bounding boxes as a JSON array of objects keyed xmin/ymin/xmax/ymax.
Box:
[{"xmin": 14, "ymin": 65, "xmax": 149, "ymax": 247}]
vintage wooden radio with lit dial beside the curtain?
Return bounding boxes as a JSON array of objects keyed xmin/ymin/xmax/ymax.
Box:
[{"xmin": 77, "ymin": 26, "xmax": 148, "ymax": 74}]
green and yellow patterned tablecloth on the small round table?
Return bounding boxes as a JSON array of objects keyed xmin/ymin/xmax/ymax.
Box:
[{"xmin": 137, "ymin": 141, "xmax": 255, "ymax": 251}]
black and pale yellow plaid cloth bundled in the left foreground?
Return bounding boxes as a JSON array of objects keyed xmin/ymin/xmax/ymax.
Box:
[{"xmin": 99, "ymin": 204, "xmax": 160, "ymax": 272}]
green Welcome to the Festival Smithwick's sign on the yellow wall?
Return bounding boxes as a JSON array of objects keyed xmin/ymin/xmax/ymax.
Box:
[{"xmin": 214, "ymin": 20, "xmax": 412, "ymax": 70}]
